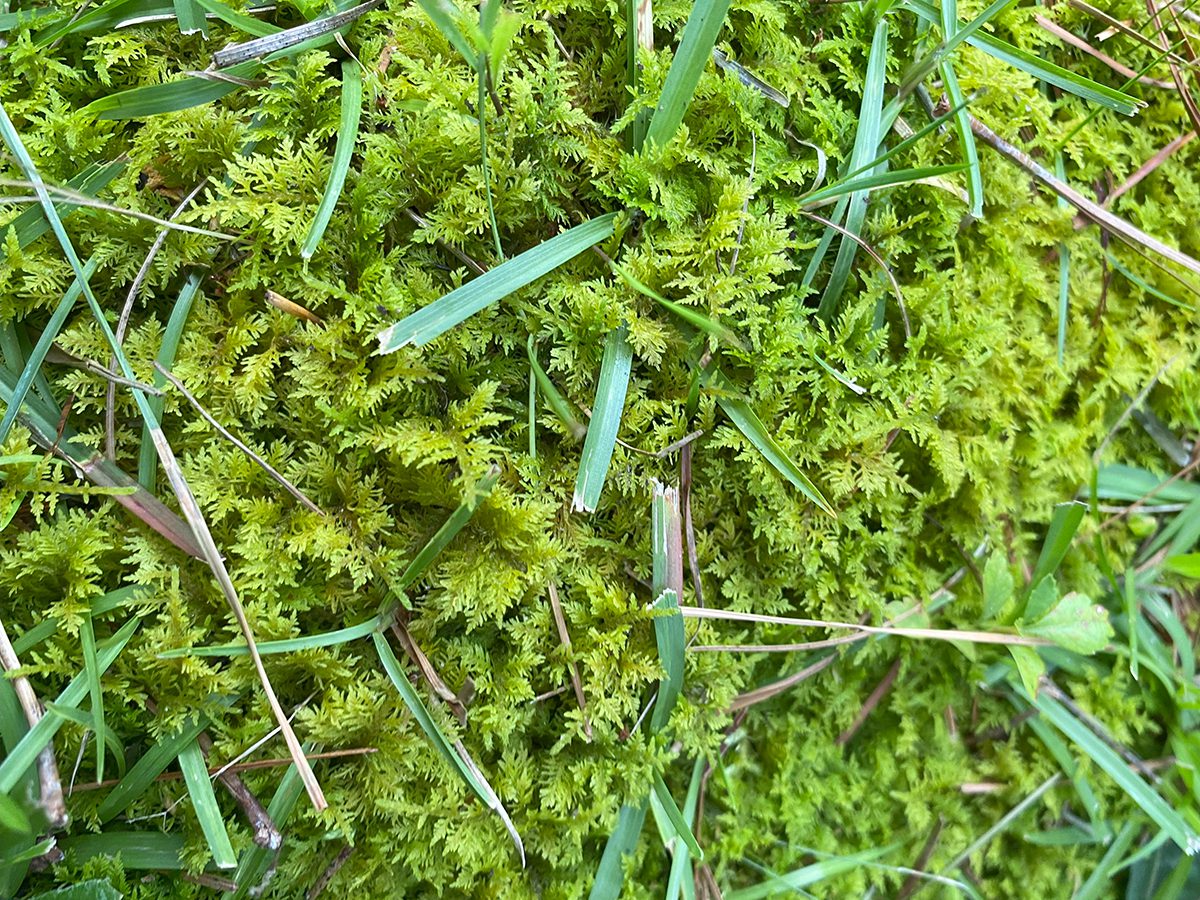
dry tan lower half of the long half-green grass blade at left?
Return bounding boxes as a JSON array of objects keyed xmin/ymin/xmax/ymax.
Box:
[{"xmin": 142, "ymin": 422, "xmax": 329, "ymax": 811}]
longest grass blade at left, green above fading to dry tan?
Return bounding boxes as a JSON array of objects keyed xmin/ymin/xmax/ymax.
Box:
[{"xmin": 0, "ymin": 95, "xmax": 328, "ymax": 811}]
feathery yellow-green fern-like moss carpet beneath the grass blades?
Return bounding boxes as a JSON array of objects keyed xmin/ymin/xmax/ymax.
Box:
[{"xmin": 0, "ymin": 0, "xmax": 1200, "ymax": 898}]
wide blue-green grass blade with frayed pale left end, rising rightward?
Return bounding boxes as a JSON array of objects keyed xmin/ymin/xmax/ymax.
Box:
[{"xmin": 377, "ymin": 212, "xmax": 617, "ymax": 354}]
